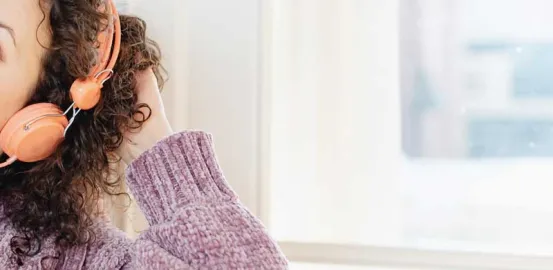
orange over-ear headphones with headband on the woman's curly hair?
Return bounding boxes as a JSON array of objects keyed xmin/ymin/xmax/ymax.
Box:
[{"xmin": 0, "ymin": 0, "xmax": 121, "ymax": 168}]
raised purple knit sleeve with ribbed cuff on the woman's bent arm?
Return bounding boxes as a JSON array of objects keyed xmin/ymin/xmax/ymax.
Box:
[{"xmin": 127, "ymin": 132, "xmax": 288, "ymax": 269}]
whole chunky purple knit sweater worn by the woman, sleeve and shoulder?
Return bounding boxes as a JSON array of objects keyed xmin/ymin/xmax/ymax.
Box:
[{"xmin": 0, "ymin": 132, "xmax": 287, "ymax": 270}]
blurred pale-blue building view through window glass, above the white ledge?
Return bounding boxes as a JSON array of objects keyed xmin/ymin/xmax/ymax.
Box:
[{"xmin": 401, "ymin": 0, "xmax": 553, "ymax": 159}]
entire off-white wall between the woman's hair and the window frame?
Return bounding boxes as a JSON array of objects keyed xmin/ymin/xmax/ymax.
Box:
[{"xmin": 131, "ymin": 0, "xmax": 261, "ymax": 214}]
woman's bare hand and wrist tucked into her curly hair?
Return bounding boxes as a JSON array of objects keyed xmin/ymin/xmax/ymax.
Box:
[{"xmin": 118, "ymin": 69, "xmax": 173, "ymax": 165}]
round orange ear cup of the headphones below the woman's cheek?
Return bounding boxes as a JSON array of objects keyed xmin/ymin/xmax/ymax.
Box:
[{"xmin": 0, "ymin": 103, "xmax": 69, "ymax": 162}]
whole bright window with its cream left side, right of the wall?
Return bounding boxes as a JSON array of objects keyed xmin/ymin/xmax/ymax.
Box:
[{"xmin": 264, "ymin": 0, "xmax": 553, "ymax": 269}]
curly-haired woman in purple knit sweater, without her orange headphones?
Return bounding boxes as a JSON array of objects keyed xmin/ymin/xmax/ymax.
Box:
[{"xmin": 0, "ymin": 0, "xmax": 287, "ymax": 269}]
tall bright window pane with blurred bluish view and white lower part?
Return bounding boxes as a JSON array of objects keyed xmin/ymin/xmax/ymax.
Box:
[{"xmin": 400, "ymin": 0, "xmax": 553, "ymax": 255}]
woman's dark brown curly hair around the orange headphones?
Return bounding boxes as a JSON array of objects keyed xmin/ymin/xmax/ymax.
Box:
[{"xmin": 0, "ymin": 0, "xmax": 165, "ymax": 261}]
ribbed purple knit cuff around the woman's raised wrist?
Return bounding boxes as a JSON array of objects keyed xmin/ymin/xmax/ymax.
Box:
[{"xmin": 126, "ymin": 131, "xmax": 237, "ymax": 225}]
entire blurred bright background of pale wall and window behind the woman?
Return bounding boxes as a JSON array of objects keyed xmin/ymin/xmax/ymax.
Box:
[{"xmin": 113, "ymin": 0, "xmax": 553, "ymax": 270}]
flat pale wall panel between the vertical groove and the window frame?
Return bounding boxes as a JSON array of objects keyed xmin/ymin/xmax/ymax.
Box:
[{"xmin": 183, "ymin": 0, "xmax": 260, "ymax": 215}]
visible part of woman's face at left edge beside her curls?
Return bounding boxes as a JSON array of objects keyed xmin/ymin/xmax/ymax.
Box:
[{"xmin": 0, "ymin": 0, "xmax": 50, "ymax": 132}]
